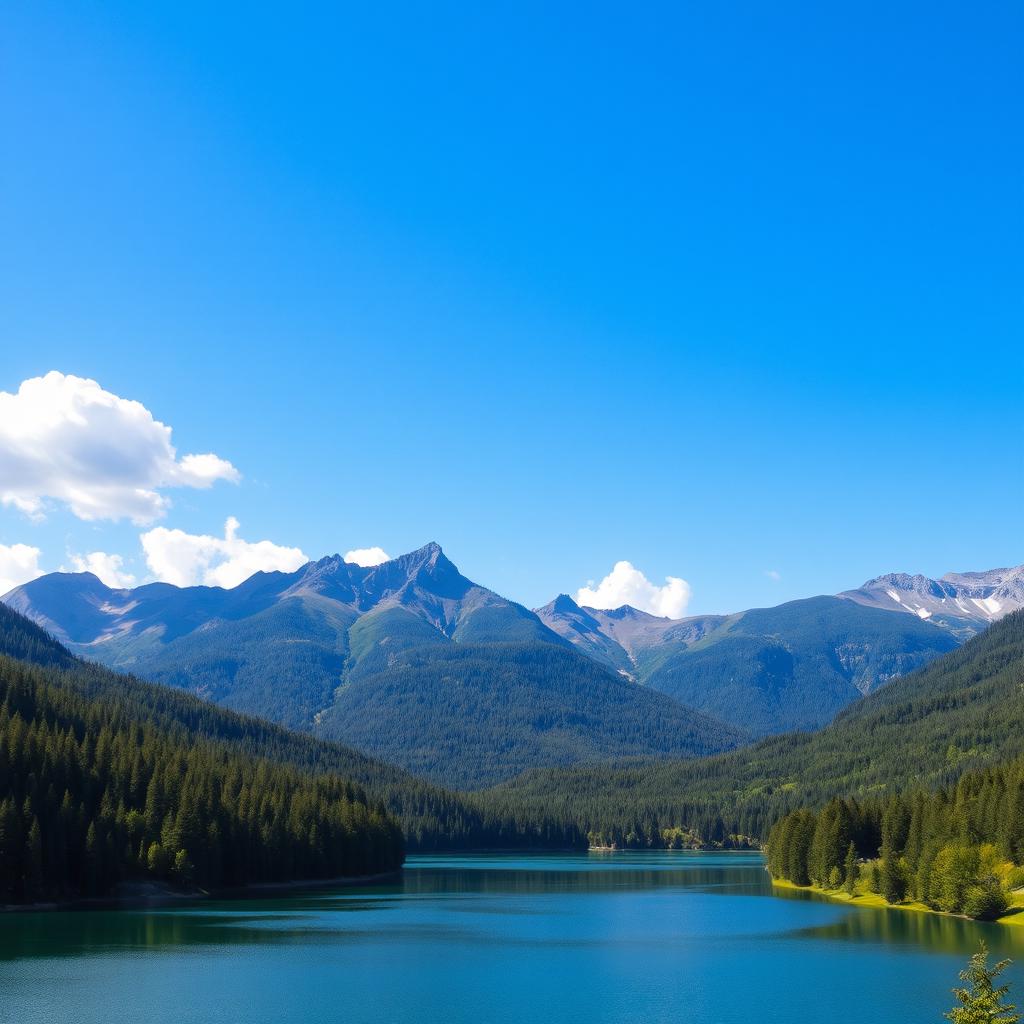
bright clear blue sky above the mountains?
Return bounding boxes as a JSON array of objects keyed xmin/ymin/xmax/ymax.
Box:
[{"xmin": 0, "ymin": 2, "xmax": 1024, "ymax": 612}]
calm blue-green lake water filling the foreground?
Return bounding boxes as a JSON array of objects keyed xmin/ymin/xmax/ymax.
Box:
[{"xmin": 0, "ymin": 853, "xmax": 1024, "ymax": 1024}]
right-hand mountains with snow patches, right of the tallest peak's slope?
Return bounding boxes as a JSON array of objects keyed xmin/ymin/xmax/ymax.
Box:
[{"xmin": 538, "ymin": 566, "xmax": 1024, "ymax": 735}]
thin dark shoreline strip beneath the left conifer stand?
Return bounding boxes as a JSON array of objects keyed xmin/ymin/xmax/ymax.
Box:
[{"xmin": 0, "ymin": 867, "xmax": 402, "ymax": 913}]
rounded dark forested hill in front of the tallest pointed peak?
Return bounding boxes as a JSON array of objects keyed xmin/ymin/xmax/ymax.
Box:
[{"xmin": 317, "ymin": 638, "xmax": 746, "ymax": 788}]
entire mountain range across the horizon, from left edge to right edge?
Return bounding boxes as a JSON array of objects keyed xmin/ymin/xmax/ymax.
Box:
[{"xmin": 3, "ymin": 544, "xmax": 1024, "ymax": 788}]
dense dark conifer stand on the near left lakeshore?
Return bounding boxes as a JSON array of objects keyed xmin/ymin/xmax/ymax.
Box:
[{"xmin": 0, "ymin": 656, "xmax": 403, "ymax": 902}]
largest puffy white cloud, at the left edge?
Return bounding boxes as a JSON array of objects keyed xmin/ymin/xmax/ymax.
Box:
[{"xmin": 0, "ymin": 370, "xmax": 240, "ymax": 523}]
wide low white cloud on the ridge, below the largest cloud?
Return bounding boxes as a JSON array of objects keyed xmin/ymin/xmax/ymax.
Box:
[{"xmin": 139, "ymin": 516, "xmax": 309, "ymax": 588}]
